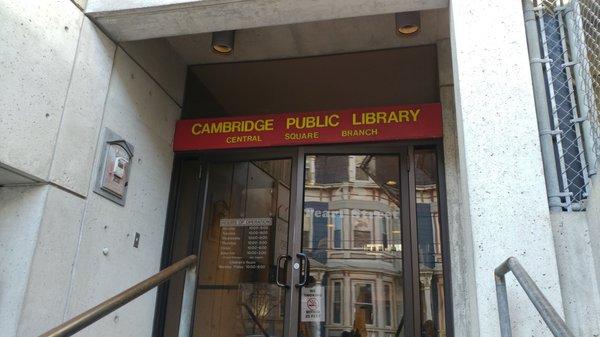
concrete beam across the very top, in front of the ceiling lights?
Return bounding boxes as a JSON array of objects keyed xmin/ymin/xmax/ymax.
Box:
[{"xmin": 86, "ymin": 0, "xmax": 448, "ymax": 42}]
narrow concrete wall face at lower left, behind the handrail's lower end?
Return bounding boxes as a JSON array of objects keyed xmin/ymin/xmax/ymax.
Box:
[{"xmin": 17, "ymin": 185, "xmax": 85, "ymax": 336}]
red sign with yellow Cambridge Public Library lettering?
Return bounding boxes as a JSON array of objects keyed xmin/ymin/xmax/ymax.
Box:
[{"xmin": 173, "ymin": 103, "xmax": 442, "ymax": 151}]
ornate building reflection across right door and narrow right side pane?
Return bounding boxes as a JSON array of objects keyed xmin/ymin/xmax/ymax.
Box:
[{"xmin": 301, "ymin": 156, "xmax": 444, "ymax": 337}]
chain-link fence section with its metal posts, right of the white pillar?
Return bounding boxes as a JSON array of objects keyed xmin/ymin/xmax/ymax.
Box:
[{"xmin": 523, "ymin": 0, "xmax": 600, "ymax": 211}]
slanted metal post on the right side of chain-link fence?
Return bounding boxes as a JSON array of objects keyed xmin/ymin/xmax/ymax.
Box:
[{"xmin": 565, "ymin": 1, "xmax": 597, "ymax": 176}]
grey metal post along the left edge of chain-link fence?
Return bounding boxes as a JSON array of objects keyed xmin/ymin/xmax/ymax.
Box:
[{"xmin": 523, "ymin": 0, "xmax": 562, "ymax": 212}]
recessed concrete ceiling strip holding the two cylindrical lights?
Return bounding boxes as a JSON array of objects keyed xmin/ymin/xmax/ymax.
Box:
[{"xmin": 167, "ymin": 8, "xmax": 449, "ymax": 65}]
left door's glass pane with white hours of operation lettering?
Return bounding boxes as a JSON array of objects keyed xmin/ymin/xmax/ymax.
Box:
[{"xmin": 193, "ymin": 159, "xmax": 292, "ymax": 337}]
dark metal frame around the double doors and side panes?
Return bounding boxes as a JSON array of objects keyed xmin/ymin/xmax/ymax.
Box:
[{"xmin": 153, "ymin": 140, "xmax": 454, "ymax": 337}]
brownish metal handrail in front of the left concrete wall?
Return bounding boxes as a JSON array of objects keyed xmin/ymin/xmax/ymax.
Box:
[{"xmin": 40, "ymin": 255, "xmax": 198, "ymax": 337}]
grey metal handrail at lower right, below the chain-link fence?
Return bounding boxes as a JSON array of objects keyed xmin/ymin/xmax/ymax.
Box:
[{"xmin": 494, "ymin": 257, "xmax": 574, "ymax": 337}]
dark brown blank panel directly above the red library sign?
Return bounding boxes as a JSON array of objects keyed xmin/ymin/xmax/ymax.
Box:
[{"xmin": 185, "ymin": 45, "xmax": 439, "ymax": 117}]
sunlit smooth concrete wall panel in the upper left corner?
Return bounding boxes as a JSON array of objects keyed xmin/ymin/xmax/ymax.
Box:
[{"xmin": 0, "ymin": 0, "xmax": 83, "ymax": 180}]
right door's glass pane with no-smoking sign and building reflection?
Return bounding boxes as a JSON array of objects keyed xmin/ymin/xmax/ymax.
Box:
[{"xmin": 298, "ymin": 154, "xmax": 413, "ymax": 337}]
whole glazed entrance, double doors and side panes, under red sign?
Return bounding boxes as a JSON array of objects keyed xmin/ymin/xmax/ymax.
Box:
[{"xmin": 162, "ymin": 144, "xmax": 452, "ymax": 337}]
